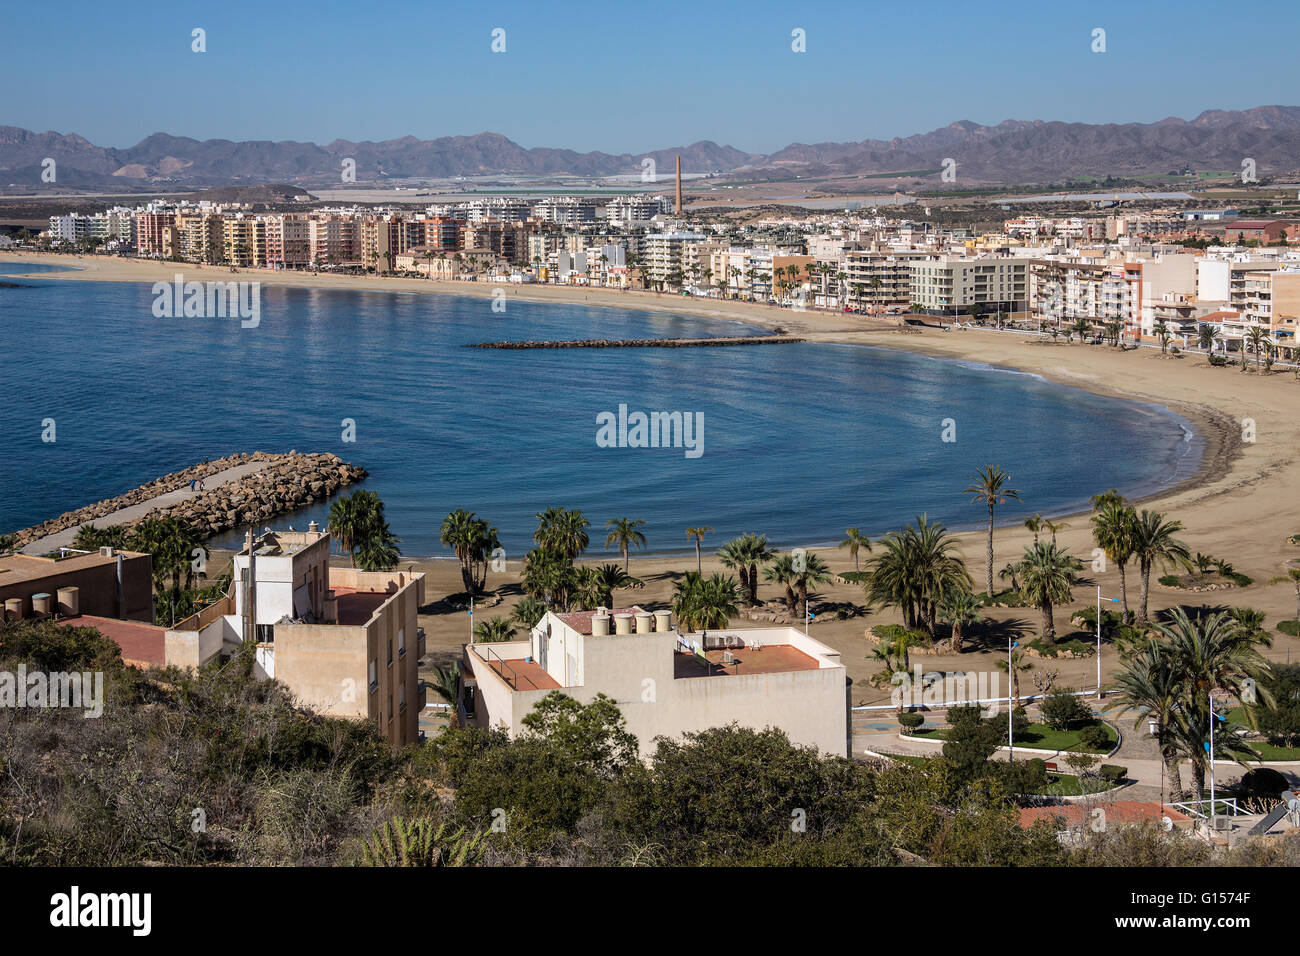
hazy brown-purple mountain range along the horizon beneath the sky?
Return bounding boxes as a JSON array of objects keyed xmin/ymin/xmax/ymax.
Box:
[{"xmin": 0, "ymin": 107, "xmax": 1300, "ymax": 189}]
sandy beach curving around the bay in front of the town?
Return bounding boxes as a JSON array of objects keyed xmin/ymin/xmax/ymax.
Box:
[{"xmin": 10, "ymin": 251, "xmax": 1300, "ymax": 704}]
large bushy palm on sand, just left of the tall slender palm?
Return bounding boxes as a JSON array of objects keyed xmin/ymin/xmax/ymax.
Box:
[{"xmin": 865, "ymin": 515, "xmax": 971, "ymax": 637}]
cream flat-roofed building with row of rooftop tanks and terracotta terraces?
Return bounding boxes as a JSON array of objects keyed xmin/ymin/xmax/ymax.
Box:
[{"xmin": 458, "ymin": 607, "xmax": 849, "ymax": 757}]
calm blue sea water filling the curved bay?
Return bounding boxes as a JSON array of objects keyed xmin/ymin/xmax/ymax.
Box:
[{"xmin": 0, "ymin": 264, "xmax": 1201, "ymax": 558}]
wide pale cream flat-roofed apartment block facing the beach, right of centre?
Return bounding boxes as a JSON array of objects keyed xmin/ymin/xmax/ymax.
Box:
[{"xmin": 907, "ymin": 255, "xmax": 1032, "ymax": 312}]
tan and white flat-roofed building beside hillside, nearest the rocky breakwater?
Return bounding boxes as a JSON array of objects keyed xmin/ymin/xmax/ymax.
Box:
[{"xmin": 166, "ymin": 522, "xmax": 425, "ymax": 747}]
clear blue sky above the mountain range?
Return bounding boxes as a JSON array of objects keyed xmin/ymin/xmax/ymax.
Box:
[{"xmin": 10, "ymin": 0, "xmax": 1300, "ymax": 152}]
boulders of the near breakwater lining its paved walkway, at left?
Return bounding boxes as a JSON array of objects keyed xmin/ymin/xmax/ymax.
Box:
[{"xmin": 14, "ymin": 451, "xmax": 367, "ymax": 549}]
